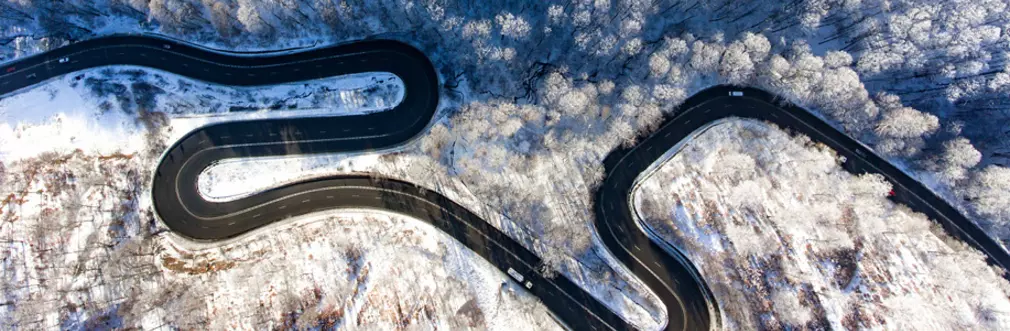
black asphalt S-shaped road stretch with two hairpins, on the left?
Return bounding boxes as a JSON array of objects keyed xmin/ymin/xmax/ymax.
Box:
[{"xmin": 0, "ymin": 36, "xmax": 633, "ymax": 330}]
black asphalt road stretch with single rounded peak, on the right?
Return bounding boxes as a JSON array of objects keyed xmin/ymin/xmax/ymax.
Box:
[{"xmin": 594, "ymin": 86, "xmax": 1010, "ymax": 330}]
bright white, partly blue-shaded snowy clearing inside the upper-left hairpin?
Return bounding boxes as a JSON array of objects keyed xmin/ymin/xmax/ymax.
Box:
[{"xmin": 0, "ymin": 66, "xmax": 404, "ymax": 159}]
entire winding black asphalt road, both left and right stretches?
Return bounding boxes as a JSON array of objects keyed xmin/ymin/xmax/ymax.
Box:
[{"xmin": 0, "ymin": 35, "xmax": 1010, "ymax": 330}]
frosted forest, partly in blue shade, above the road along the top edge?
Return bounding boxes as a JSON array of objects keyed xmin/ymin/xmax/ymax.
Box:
[{"xmin": 0, "ymin": 0, "xmax": 1010, "ymax": 268}]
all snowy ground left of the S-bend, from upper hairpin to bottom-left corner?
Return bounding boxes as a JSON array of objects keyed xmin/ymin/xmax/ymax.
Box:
[{"xmin": 0, "ymin": 68, "xmax": 577, "ymax": 330}]
